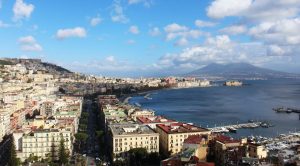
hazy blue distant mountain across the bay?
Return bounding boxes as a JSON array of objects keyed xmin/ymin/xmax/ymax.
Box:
[{"xmin": 185, "ymin": 63, "xmax": 299, "ymax": 80}]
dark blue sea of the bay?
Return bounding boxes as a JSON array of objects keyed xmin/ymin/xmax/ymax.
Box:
[{"xmin": 129, "ymin": 79, "xmax": 300, "ymax": 138}]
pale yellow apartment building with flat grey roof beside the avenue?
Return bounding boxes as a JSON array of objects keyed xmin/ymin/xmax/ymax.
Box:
[{"xmin": 109, "ymin": 124, "xmax": 159, "ymax": 159}]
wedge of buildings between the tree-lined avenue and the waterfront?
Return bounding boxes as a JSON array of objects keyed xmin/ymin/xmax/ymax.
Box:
[{"xmin": 98, "ymin": 95, "xmax": 268, "ymax": 166}]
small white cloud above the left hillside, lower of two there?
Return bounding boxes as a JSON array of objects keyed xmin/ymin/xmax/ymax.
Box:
[{"xmin": 18, "ymin": 36, "xmax": 43, "ymax": 51}]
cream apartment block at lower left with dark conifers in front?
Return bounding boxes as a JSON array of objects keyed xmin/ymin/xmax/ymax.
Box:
[{"xmin": 13, "ymin": 129, "xmax": 73, "ymax": 162}]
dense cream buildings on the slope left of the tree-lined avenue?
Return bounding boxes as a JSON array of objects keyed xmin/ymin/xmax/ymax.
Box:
[{"xmin": 0, "ymin": 60, "xmax": 83, "ymax": 162}]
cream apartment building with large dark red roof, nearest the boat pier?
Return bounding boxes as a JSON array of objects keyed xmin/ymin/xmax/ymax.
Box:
[{"xmin": 156, "ymin": 122, "xmax": 211, "ymax": 155}]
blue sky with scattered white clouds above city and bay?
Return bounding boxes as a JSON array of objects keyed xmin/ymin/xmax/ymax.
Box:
[{"xmin": 0, "ymin": 0, "xmax": 300, "ymax": 77}]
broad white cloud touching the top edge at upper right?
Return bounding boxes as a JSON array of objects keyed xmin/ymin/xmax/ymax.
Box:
[{"xmin": 207, "ymin": 0, "xmax": 300, "ymax": 22}]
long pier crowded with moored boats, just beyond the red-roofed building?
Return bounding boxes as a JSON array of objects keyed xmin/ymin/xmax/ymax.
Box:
[{"xmin": 208, "ymin": 122, "xmax": 264, "ymax": 133}]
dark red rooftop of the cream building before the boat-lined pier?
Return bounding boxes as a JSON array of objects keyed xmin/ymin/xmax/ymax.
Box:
[{"xmin": 157, "ymin": 122, "xmax": 209, "ymax": 134}]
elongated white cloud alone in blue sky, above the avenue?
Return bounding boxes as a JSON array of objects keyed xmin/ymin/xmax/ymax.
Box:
[{"xmin": 56, "ymin": 27, "xmax": 87, "ymax": 39}]
